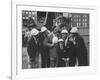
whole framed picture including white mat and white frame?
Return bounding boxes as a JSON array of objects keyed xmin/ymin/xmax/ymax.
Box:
[{"xmin": 12, "ymin": 2, "xmax": 97, "ymax": 80}]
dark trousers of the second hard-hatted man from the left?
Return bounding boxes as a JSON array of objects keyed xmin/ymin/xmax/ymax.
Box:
[{"xmin": 41, "ymin": 52, "xmax": 50, "ymax": 68}]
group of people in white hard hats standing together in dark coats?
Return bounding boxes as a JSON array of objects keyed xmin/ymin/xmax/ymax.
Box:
[{"xmin": 23, "ymin": 16, "xmax": 89, "ymax": 68}]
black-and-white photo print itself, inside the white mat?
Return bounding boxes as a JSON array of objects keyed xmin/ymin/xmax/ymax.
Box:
[{"xmin": 21, "ymin": 10, "xmax": 90, "ymax": 69}]
